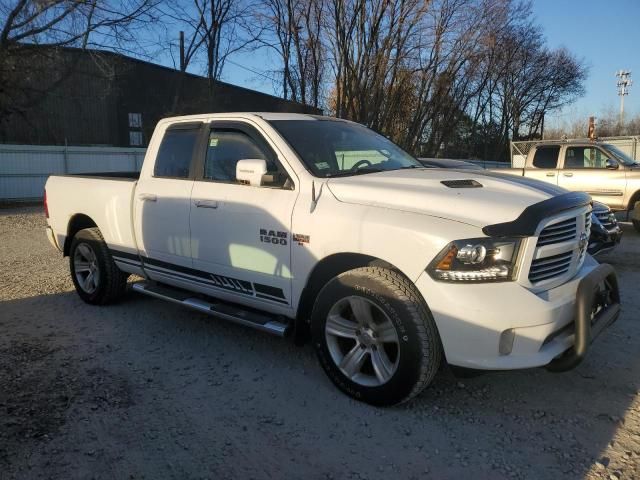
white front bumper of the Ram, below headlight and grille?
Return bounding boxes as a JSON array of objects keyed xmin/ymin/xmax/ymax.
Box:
[{"xmin": 416, "ymin": 257, "xmax": 620, "ymax": 370}]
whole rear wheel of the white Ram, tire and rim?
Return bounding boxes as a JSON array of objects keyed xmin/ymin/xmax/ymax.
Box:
[{"xmin": 69, "ymin": 228, "xmax": 128, "ymax": 305}]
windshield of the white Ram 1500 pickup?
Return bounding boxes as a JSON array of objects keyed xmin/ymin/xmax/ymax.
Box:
[{"xmin": 270, "ymin": 120, "xmax": 422, "ymax": 177}]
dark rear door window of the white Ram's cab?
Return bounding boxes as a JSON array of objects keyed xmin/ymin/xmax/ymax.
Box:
[{"xmin": 153, "ymin": 128, "xmax": 200, "ymax": 178}]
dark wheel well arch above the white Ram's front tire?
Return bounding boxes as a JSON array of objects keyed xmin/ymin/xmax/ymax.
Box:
[{"xmin": 295, "ymin": 252, "xmax": 406, "ymax": 344}]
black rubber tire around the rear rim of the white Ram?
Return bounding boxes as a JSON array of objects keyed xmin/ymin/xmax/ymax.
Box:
[{"xmin": 69, "ymin": 228, "xmax": 129, "ymax": 305}]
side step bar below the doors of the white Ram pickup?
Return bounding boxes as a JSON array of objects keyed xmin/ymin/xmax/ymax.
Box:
[{"xmin": 131, "ymin": 282, "xmax": 288, "ymax": 337}]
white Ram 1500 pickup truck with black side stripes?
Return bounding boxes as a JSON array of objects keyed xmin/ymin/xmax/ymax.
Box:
[{"xmin": 45, "ymin": 113, "xmax": 620, "ymax": 405}]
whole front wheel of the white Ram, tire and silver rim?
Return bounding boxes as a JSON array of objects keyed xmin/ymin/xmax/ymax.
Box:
[{"xmin": 312, "ymin": 267, "xmax": 442, "ymax": 406}]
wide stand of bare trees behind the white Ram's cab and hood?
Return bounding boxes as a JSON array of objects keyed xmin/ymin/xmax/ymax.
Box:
[{"xmin": 250, "ymin": 0, "xmax": 586, "ymax": 158}]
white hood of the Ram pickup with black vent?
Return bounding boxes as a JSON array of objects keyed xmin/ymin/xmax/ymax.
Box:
[{"xmin": 327, "ymin": 168, "xmax": 566, "ymax": 228}]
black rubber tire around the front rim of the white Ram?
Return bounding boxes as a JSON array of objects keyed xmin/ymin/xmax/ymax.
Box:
[{"xmin": 311, "ymin": 267, "xmax": 442, "ymax": 406}]
